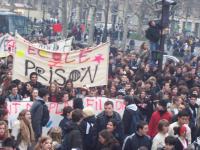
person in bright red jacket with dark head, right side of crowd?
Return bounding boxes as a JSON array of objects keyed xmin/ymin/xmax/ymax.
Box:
[{"xmin": 148, "ymin": 100, "xmax": 172, "ymax": 138}]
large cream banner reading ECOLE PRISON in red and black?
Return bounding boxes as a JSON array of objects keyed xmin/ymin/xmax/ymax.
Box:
[{"xmin": 13, "ymin": 34, "xmax": 109, "ymax": 87}]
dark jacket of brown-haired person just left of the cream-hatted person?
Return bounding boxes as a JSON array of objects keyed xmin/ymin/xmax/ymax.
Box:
[{"xmin": 61, "ymin": 121, "xmax": 83, "ymax": 150}]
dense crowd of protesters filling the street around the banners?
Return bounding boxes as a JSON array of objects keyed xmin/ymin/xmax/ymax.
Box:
[{"xmin": 0, "ymin": 22, "xmax": 200, "ymax": 150}]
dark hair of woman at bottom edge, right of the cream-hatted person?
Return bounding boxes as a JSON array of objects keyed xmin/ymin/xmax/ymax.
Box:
[{"xmin": 99, "ymin": 129, "xmax": 118, "ymax": 145}]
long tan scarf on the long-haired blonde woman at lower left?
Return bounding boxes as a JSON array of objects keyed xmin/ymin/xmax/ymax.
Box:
[{"xmin": 20, "ymin": 120, "xmax": 35, "ymax": 145}]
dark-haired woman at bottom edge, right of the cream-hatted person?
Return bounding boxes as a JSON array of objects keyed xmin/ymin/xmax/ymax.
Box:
[{"xmin": 99, "ymin": 130, "xmax": 121, "ymax": 150}]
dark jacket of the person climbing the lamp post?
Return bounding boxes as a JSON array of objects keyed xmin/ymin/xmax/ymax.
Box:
[{"xmin": 146, "ymin": 26, "xmax": 160, "ymax": 43}]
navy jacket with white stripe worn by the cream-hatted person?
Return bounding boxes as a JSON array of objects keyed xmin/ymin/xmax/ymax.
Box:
[{"xmin": 80, "ymin": 116, "xmax": 96, "ymax": 150}]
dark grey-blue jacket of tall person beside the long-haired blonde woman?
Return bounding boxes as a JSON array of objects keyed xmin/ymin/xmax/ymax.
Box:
[{"xmin": 30, "ymin": 98, "xmax": 50, "ymax": 140}]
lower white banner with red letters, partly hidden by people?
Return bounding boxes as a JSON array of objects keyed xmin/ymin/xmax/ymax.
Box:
[{"xmin": 7, "ymin": 97, "xmax": 125, "ymax": 133}]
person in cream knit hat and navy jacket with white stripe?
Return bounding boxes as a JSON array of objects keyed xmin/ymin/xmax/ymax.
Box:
[{"xmin": 80, "ymin": 107, "xmax": 96, "ymax": 150}]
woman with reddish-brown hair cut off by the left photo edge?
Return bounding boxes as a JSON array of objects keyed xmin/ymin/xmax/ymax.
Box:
[{"xmin": 0, "ymin": 121, "xmax": 9, "ymax": 148}]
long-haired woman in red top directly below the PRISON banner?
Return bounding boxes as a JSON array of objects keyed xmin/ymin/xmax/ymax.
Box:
[{"xmin": 49, "ymin": 82, "xmax": 61, "ymax": 102}]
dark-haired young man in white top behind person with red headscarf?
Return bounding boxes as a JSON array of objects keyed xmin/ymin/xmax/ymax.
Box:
[{"xmin": 168, "ymin": 110, "xmax": 191, "ymax": 144}]
